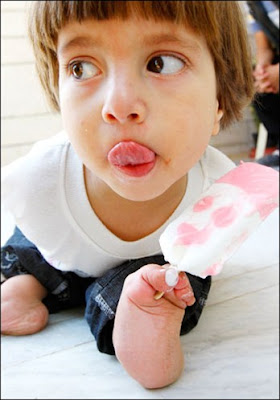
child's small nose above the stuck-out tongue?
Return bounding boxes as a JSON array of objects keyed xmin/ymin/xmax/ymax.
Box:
[{"xmin": 102, "ymin": 76, "xmax": 147, "ymax": 124}]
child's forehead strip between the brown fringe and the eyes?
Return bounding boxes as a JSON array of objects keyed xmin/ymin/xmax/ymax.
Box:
[{"xmin": 57, "ymin": 17, "xmax": 207, "ymax": 55}]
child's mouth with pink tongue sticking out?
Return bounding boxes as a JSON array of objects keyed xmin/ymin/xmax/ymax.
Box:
[{"xmin": 108, "ymin": 141, "xmax": 156, "ymax": 177}]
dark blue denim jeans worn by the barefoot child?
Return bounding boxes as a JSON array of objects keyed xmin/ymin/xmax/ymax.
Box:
[{"xmin": 1, "ymin": 228, "xmax": 211, "ymax": 355}]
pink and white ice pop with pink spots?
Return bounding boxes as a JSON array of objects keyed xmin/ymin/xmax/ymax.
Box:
[{"xmin": 159, "ymin": 162, "xmax": 279, "ymax": 278}]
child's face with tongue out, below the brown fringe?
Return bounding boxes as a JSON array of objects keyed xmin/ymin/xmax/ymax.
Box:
[{"xmin": 57, "ymin": 18, "xmax": 222, "ymax": 201}]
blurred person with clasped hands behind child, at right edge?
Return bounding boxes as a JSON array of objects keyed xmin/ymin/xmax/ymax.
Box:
[{"xmin": 246, "ymin": 1, "xmax": 279, "ymax": 168}]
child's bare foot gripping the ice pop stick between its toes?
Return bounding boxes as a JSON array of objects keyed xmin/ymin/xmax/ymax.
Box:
[{"xmin": 113, "ymin": 264, "xmax": 195, "ymax": 388}]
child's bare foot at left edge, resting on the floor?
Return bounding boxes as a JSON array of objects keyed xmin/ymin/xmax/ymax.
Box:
[{"xmin": 1, "ymin": 275, "xmax": 49, "ymax": 336}]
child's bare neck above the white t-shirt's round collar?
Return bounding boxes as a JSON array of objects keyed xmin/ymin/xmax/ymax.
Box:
[{"xmin": 85, "ymin": 173, "xmax": 187, "ymax": 241}]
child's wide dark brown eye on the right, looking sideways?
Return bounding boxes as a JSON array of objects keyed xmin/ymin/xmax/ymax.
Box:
[{"xmin": 147, "ymin": 55, "xmax": 185, "ymax": 75}]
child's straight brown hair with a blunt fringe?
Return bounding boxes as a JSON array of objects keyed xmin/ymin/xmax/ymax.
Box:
[{"xmin": 28, "ymin": 1, "xmax": 253, "ymax": 128}]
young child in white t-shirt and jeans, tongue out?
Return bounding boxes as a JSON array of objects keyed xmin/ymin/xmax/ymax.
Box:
[{"xmin": 1, "ymin": 1, "xmax": 253, "ymax": 388}]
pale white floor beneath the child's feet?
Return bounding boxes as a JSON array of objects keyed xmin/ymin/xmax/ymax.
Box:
[{"xmin": 1, "ymin": 213, "xmax": 279, "ymax": 399}]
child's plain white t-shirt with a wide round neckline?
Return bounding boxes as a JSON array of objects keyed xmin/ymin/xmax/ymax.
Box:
[{"xmin": 2, "ymin": 132, "xmax": 278, "ymax": 277}]
